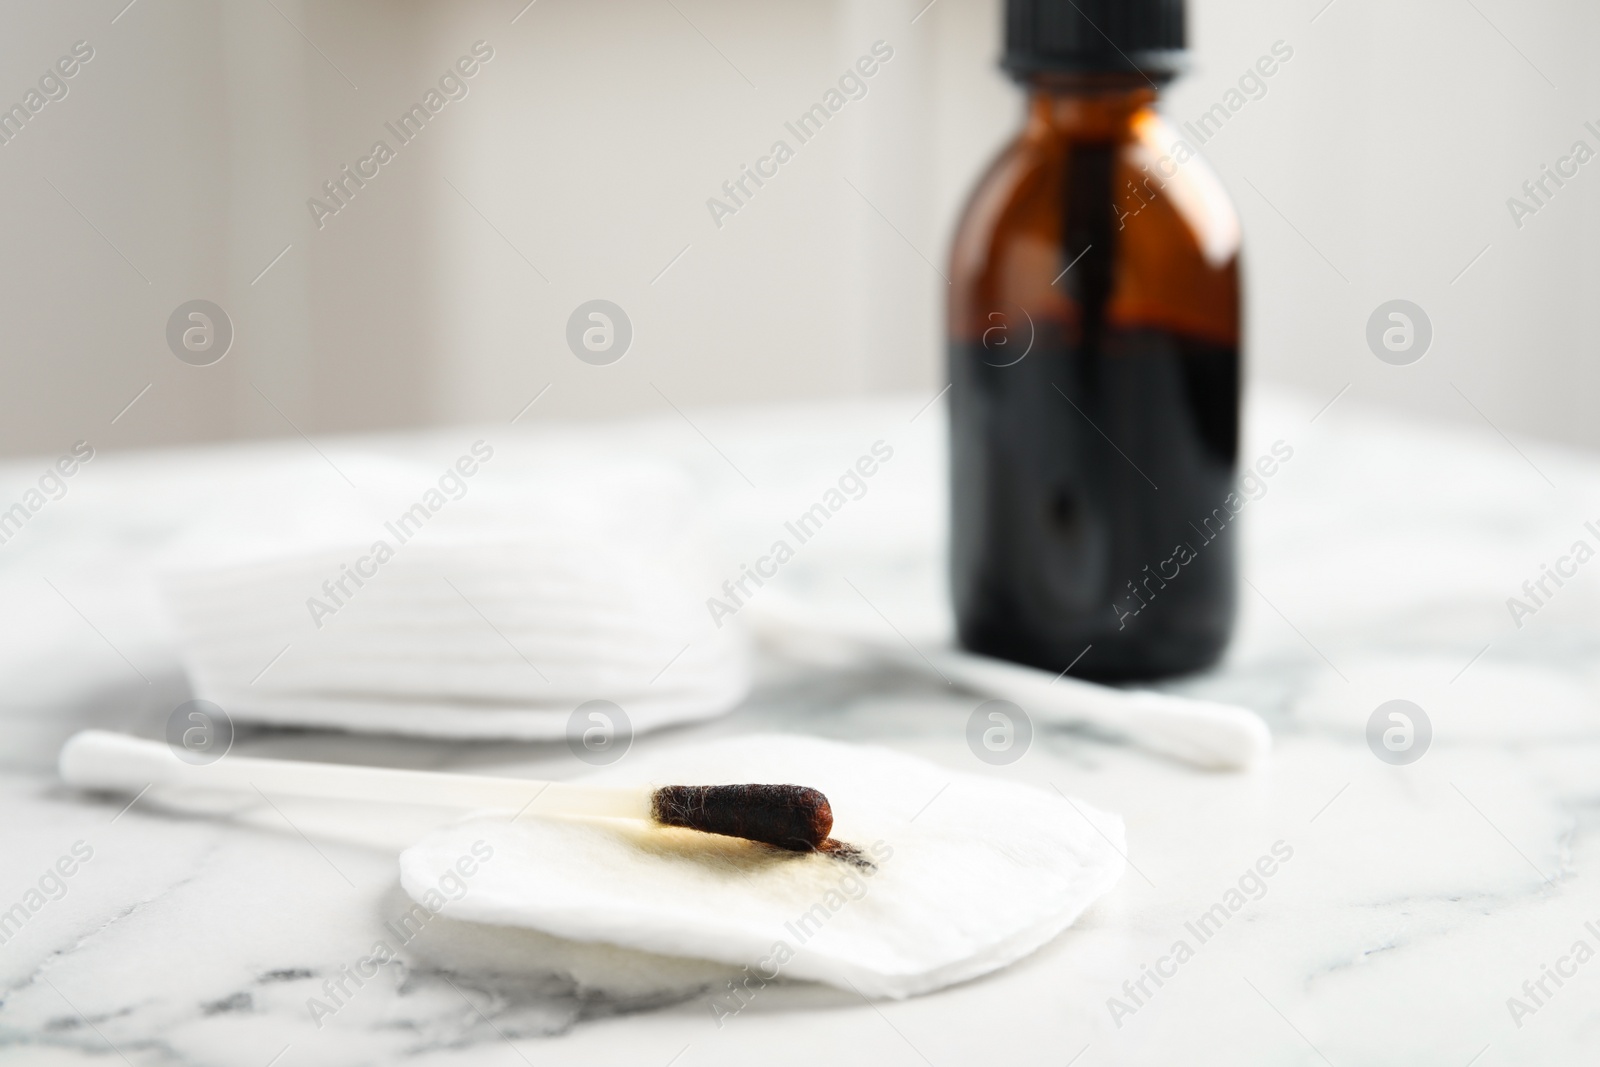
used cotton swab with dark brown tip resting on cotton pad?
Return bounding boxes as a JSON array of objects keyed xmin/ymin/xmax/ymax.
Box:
[{"xmin": 59, "ymin": 729, "xmax": 834, "ymax": 853}]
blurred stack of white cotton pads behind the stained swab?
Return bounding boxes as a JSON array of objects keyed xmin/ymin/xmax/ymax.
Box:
[{"xmin": 163, "ymin": 454, "xmax": 749, "ymax": 739}]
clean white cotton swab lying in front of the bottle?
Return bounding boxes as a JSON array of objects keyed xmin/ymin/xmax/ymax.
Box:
[{"xmin": 747, "ymin": 601, "xmax": 1272, "ymax": 771}]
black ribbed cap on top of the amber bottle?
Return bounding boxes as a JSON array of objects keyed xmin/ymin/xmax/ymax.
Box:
[{"xmin": 1000, "ymin": 0, "xmax": 1184, "ymax": 78}]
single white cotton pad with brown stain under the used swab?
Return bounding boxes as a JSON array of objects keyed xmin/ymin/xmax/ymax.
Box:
[{"xmin": 400, "ymin": 736, "xmax": 1125, "ymax": 997}]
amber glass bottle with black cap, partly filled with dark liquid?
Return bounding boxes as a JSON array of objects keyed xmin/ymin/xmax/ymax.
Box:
[{"xmin": 949, "ymin": 0, "xmax": 1240, "ymax": 680}]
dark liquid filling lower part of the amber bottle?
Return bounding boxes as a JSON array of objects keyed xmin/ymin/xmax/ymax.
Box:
[{"xmin": 949, "ymin": 144, "xmax": 1242, "ymax": 680}]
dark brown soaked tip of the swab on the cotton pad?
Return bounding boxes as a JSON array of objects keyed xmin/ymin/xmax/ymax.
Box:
[{"xmin": 650, "ymin": 785, "xmax": 834, "ymax": 853}]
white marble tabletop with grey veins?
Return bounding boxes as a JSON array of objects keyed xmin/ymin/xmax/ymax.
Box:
[{"xmin": 0, "ymin": 397, "xmax": 1600, "ymax": 1067}]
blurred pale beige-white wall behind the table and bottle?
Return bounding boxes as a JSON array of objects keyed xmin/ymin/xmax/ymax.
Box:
[{"xmin": 0, "ymin": 0, "xmax": 1600, "ymax": 454}]
